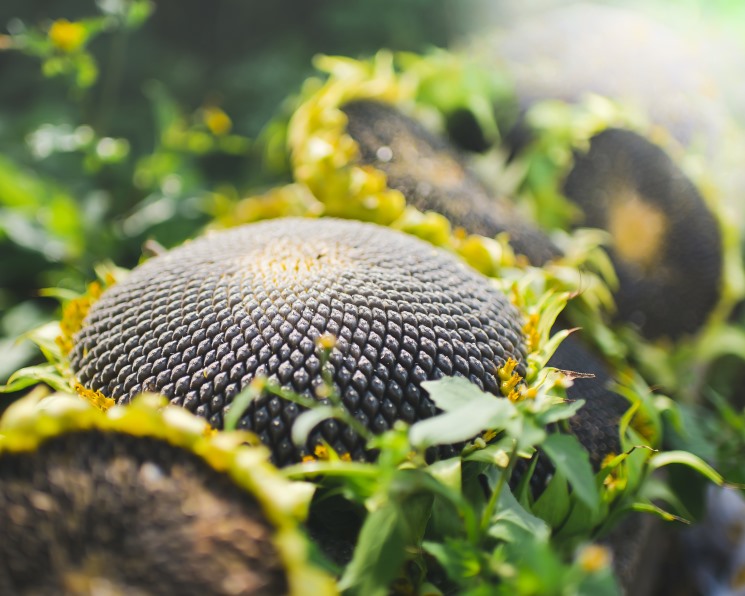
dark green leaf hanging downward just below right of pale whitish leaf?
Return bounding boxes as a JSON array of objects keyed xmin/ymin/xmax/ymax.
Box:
[{"xmin": 541, "ymin": 433, "xmax": 600, "ymax": 511}]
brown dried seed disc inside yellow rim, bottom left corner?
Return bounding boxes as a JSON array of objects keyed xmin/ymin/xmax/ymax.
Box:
[{"xmin": 0, "ymin": 430, "xmax": 288, "ymax": 596}]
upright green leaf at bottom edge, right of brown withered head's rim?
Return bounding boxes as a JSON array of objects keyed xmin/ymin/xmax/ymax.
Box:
[{"xmin": 338, "ymin": 502, "xmax": 404, "ymax": 596}]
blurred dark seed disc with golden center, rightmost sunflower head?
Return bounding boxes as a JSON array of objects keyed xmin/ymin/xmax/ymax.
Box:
[{"xmin": 564, "ymin": 129, "xmax": 723, "ymax": 338}]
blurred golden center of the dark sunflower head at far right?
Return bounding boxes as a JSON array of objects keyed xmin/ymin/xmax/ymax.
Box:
[{"xmin": 608, "ymin": 189, "xmax": 667, "ymax": 271}]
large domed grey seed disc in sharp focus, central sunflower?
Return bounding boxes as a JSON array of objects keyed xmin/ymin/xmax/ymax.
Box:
[{"xmin": 71, "ymin": 219, "xmax": 525, "ymax": 465}]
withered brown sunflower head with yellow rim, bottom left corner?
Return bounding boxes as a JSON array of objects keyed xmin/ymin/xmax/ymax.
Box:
[{"xmin": 0, "ymin": 396, "xmax": 330, "ymax": 594}]
